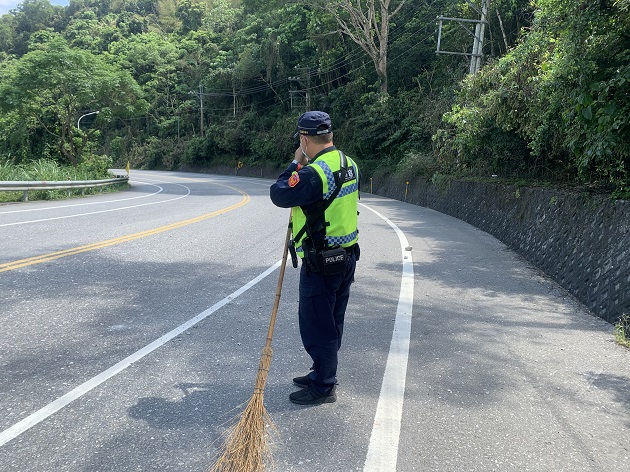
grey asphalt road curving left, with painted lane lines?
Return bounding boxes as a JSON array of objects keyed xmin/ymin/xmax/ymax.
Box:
[{"xmin": 0, "ymin": 171, "xmax": 630, "ymax": 472}]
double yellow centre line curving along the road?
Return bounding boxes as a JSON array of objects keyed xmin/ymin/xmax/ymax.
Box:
[{"xmin": 0, "ymin": 191, "xmax": 251, "ymax": 272}]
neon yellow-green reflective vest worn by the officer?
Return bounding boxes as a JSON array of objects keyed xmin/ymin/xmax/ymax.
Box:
[{"xmin": 292, "ymin": 149, "xmax": 359, "ymax": 258}]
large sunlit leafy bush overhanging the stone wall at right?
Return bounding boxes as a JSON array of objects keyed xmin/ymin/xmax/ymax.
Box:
[{"xmin": 434, "ymin": 0, "xmax": 630, "ymax": 194}]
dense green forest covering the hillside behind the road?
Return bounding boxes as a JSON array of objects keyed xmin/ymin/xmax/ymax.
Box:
[{"xmin": 0, "ymin": 0, "xmax": 630, "ymax": 198}]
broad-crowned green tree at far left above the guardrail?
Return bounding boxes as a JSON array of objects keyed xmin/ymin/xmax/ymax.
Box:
[{"xmin": 0, "ymin": 37, "xmax": 146, "ymax": 165}]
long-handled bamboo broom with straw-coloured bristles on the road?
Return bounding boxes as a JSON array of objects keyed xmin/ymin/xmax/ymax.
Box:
[{"xmin": 210, "ymin": 218, "xmax": 291, "ymax": 472}]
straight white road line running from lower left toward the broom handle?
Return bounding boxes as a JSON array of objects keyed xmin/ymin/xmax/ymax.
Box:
[{"xmin": 0, "ymin": 260, "xmax": 282, "ymax": 447}]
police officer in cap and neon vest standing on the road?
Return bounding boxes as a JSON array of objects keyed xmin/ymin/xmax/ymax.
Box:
[{"xmin": 270, "ymin": 111, "xmax": 359, "ymax": 405}]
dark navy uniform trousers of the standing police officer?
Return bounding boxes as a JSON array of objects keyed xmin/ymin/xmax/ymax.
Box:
[{"xmin": 299, "ymin": 254, "xmax": 356, "ymax": 393}]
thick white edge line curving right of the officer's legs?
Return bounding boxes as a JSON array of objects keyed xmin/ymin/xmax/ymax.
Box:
[{"xmin": 360, "ymin": 204, "xmax": 414, "ymax": 472}]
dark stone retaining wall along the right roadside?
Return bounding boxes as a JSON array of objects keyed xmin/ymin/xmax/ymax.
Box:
[{"xmin": 372, "ymin": 177, "xmax": 630, "ymax": 323}]
